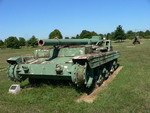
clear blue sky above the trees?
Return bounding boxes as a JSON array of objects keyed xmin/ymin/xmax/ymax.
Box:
[{"xmin": 0, "ymin": 0, "xmax": 150, "ymax": 40}]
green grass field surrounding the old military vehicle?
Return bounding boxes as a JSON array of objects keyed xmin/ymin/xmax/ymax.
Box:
[{"xmin": 0, "ymin": 40, "xmax": 150, "ymax": 113}]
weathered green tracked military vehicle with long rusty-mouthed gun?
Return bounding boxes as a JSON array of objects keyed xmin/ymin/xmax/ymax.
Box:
[{"xmin": 7, "ymin": 36, "xmax": 120, "ymax": 88}]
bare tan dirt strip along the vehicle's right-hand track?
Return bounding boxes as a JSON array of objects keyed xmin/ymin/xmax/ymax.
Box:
[{"xmin": 76, "ymin": 66, "xmax": 123, "ymax": 103}]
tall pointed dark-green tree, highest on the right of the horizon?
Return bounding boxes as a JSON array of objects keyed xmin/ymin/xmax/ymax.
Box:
[{"xmin": 113, "ymin": 25, "xmax": 126, "ymax": 41}]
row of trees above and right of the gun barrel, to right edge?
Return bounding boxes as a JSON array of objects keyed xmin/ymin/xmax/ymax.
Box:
[{"xmin": 49, "ymin": 25, "xmax": 150, "ymax": 40}]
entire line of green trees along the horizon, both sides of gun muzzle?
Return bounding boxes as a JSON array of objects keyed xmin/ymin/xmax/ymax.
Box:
[{"xmin": 0, "ymin": 25, "xmax": 150, "ymax": 49}]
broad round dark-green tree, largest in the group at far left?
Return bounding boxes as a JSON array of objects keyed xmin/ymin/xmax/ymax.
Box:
[{"xmin": 5, "ymin": 36, "xmax": 19, "ymax": 49}]
